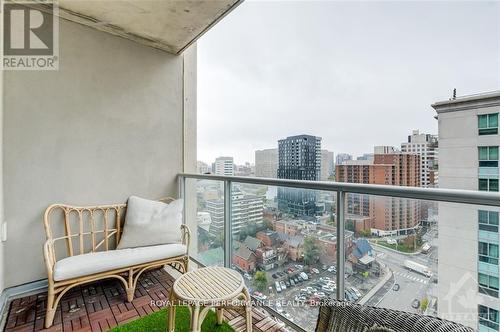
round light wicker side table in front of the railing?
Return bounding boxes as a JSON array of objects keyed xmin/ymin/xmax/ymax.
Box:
[{"xmin": 167, "ymin": 267, "xmax": 252, "ymax": 332}]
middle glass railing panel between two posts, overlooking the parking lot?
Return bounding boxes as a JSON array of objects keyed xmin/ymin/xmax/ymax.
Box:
[{"xmin": 231, "ymin": 183, "xmax": 338, "ymax": 331}]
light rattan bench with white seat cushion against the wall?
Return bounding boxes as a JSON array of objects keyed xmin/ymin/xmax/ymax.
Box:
[{"xmin": 43, "ymin": 198, "xmax": 190, "ymax": 328}]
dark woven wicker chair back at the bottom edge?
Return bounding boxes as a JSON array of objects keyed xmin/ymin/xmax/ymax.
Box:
[{"xmin": 316, "ymin": 300, "xmax": 474, "ymax": 332}]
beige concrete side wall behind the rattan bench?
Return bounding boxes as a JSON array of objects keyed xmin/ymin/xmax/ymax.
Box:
[{"xmin": 3, "ymin": 20, "xmax": 196, "ymax": 287}]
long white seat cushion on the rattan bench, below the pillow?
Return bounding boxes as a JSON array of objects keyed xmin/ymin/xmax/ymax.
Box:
[{"xmin": 54, "ymin": 243, "xmax": 186, "ymax": 281}]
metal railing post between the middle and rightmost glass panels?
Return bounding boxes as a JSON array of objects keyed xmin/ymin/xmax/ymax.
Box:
[{"xmin": 336, "ymin": 191, "xmax": 346, "ymax": 300}]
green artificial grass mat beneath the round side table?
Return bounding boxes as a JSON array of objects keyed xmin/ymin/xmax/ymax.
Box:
[{"xmin": 110, "ymin": 306, "xmax": 234, "ymax": 332}]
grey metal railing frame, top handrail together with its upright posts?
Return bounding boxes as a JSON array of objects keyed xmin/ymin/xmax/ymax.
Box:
[{"xmin": 178, "ymin": 173, "xmax": 500, "ymax": 332}]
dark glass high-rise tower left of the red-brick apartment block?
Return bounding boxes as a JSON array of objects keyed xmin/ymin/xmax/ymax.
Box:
[{"xmin": 278, "ymin": 135, "xmax": 321, "ymax": 216}]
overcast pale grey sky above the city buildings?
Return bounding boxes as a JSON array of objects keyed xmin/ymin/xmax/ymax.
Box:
[{"xmin": 198, "ymin": 1, "xmax": 500, "ymax": 164}]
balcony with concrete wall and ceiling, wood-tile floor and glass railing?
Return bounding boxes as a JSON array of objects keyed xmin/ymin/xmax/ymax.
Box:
[{"xmin": 0, "ymin": 0, "xmax": 500, "ymax": 331}]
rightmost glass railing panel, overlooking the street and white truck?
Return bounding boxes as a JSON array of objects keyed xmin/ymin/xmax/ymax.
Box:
[{"xmin": 345, "ymin": 194, "xmax": 500, "ymax": 329}]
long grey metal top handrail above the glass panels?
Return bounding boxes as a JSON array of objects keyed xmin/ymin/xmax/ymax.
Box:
[{"xmin": 179, "ymin": 173, "xmax": 500, "ymax": 207}]
